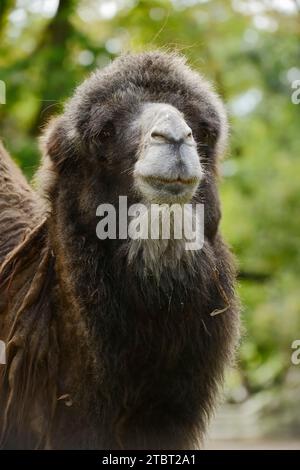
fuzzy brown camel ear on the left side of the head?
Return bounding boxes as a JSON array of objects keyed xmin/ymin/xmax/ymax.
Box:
[{"xmin": 41, "ymin": 116, "xmax": 76, "ymax": 170}]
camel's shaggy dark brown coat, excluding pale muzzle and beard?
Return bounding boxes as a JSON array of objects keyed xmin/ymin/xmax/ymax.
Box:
[{"xmin": 0, "ymin": 52, "xmax": 239, "ymax": 449}]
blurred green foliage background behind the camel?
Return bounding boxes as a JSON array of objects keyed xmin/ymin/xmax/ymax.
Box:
[{"xmin": 0, "ymin": 0, "xmax": 300, "ymax": 448}]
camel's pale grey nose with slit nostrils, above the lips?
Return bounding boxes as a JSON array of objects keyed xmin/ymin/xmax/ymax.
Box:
[{"xmin": 150, "ymin": 112, "xmax": 193, "ymax": 143}]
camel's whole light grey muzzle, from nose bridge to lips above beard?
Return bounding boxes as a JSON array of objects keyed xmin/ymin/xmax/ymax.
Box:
[{"xmin": 134, "ymin": 103, "xmax": 202, "ymax": 203}]
